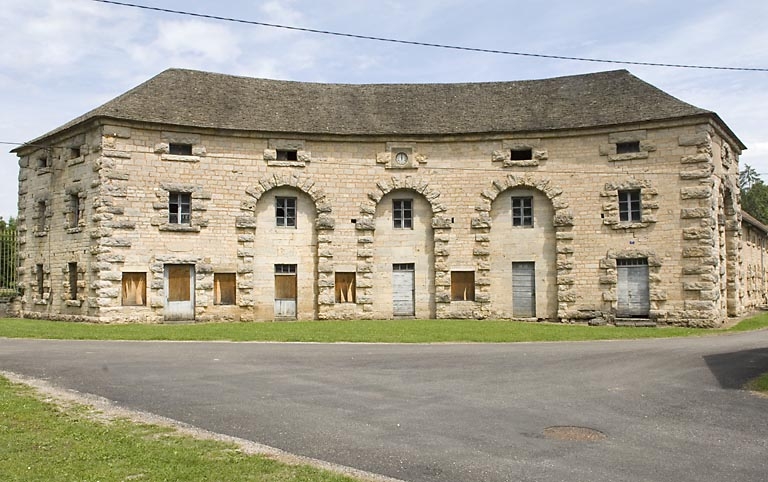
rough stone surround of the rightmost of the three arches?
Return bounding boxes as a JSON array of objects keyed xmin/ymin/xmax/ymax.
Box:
[{"xmin": 472, "ymin": 174, "xmax": 576, "ymax": 320}]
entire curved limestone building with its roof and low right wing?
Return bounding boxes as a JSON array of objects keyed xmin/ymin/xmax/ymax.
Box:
[{"xmin": 14, "ymin": 69, "xmax": 766, "ymax": 326}]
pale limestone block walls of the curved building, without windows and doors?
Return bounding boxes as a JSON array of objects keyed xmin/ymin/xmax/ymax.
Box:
[{"xmin": 13, "ymin": 117, "xmax": 759, "ymax": 326}]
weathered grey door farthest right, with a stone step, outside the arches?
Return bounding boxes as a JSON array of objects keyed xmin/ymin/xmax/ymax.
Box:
[{"xmin": 616, "ymin": 258, "xmax": 651, "ymax": 318}]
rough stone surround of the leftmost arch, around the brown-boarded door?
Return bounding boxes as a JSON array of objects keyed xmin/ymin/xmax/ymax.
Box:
[{"xmin": 235, "ymin": 174, "xmax": 335, "ymax": 319}]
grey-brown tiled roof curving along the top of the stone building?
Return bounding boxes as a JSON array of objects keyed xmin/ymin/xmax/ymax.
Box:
[{"xmin": 21, "ymin": 69, "xmax": 730, "ymax": 144}]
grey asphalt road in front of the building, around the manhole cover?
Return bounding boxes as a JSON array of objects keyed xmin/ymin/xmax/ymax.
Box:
[{"xmin": 0, "ymin": 331, "xmax": 768, "ymax": 482}]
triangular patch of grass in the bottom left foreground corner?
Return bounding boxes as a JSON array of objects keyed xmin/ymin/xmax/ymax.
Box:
[{"xmin": 0, "ymin": 377, "xmax": 356, "ymax": 482}]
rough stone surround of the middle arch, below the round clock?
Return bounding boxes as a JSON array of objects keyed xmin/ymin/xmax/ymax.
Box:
[{"xmin": 355, "ymin": 176, "xmax": 451, "ymax": 318}]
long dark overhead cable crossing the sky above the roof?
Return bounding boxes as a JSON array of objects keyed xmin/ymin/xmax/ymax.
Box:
[{"xmin": 92, "ymin": 0, "xmax": 768, "ymax": 72}]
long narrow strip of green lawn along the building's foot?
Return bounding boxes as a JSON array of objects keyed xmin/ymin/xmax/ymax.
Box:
[{"xmin": 0, "ymin": 314, "xmax": 768, "ymax": 343}]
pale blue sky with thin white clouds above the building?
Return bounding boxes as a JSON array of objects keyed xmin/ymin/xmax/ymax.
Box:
[{"xmin": 0, "ymin": 0, "xmax": 768, "ymax": 219}]
